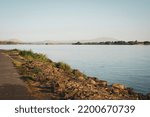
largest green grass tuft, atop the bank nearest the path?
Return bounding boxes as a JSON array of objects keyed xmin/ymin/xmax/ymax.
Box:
[{"xmin": 19, "ymin": 50, "xmax": 49, "ymax": 61}]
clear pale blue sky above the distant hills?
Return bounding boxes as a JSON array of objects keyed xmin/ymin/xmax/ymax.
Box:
[{"xmin": 0, "ymin": 0, "xmax": 150, "ymax": 42}]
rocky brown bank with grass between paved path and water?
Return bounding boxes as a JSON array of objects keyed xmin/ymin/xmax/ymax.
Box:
[{"xmin": 3, "ymin": 49, "xmax": 150, "ymax": 100}]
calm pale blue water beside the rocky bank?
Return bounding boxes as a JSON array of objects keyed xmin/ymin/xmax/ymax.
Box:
[{"xmin": 0, "ymin": 45, "xmax": 150, "ymax": 93}]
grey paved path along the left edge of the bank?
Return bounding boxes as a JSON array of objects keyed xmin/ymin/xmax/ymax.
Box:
[{"xmin": 0, "ymin": 50, "xmax": 31, "ymax": 100}]
